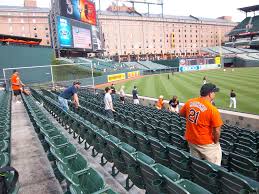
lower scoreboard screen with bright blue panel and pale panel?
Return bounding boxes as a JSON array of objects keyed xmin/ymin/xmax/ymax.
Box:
[{"xmin": 57, "ymin": 16, "xmax": 93, "ymax": 51}]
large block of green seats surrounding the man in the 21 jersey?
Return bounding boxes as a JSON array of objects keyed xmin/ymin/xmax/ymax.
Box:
[{"xmin": 30, "ymin": 90, "xmax": 259, "ymax": 194}]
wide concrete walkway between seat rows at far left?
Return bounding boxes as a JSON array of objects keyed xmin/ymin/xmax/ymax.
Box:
[{"xmin": 11, "ymin": 103, "xmax": 63, "ymax": 194}]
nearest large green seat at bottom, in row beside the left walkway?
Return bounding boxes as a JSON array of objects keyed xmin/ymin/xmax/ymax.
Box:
[{"xmin": 69, "ymin": 168, "xmax": 105, "ymax": 194}]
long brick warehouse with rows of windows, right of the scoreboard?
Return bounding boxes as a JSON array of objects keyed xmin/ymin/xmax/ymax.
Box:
[{"xmin": 98, "ymin": 6, "xmax": 239, "ymax": 56}]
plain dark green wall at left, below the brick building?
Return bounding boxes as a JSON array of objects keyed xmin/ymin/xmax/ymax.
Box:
[{"xmin": 0, "ymin": 45, "xmax": 53, "ymax": 83}]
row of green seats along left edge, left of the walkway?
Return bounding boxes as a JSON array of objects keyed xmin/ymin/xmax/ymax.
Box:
[{"xmin": 0, "ymin": 91, "xmax": 19, "ymax": 194}]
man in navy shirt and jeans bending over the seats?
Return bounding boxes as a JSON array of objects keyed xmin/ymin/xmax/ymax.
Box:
[{"xmin": 58, "ymin": 81, "xmax": 81, "ymax": 111}]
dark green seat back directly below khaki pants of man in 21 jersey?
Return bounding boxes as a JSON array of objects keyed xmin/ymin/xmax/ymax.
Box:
[{"xmin": 190, "ymin": 156, "xmax": 221, "ymax": 193}]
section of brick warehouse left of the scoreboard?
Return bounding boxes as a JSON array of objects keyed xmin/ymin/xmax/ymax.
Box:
[{"xmin": 0, "ymin": 0, "xmax": 51, "ymax": 46}]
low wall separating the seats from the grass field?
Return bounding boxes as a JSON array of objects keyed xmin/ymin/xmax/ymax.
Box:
[{"xmin": 124, "ymin": 94, "xmax": 259, "ymax": 131}]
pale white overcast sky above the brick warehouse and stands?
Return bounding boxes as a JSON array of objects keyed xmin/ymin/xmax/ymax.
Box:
[{"xmin": 0, "ymin": 0, "xmax": 259, "ymax": 21}]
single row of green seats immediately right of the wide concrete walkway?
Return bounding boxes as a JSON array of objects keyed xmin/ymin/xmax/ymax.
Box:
[{"xmin": 23, "ymin": 93, "xmax": 118, "ymax": 194}]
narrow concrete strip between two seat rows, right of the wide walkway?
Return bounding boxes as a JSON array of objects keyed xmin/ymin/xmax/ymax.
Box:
[{"xmin": 39, "ymin": 104, "xmax": 145, "ymax": 194}]
